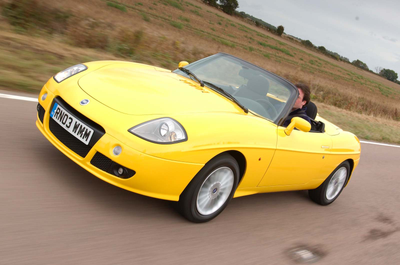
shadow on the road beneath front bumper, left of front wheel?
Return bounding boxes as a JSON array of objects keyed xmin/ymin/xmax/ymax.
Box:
[{"xmin": 36, "ymin": 142, "xmax": 184, "ymax": 221}]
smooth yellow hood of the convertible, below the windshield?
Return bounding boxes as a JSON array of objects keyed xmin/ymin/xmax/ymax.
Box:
[{"xmin": 78, "ymin": 63, "xmax": 240, "ymax": 115}]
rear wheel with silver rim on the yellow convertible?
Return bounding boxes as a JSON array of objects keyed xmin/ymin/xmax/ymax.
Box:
[{"xmin": 308, "ymin": 161, "xmax": 350, "ymax": 205}]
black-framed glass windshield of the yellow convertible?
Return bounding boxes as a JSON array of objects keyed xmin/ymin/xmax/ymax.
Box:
[{"xmin": 174, "ymin": 53, "xmax": 296, "ymax": 122}]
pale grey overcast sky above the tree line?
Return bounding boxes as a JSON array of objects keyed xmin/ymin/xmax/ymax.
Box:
[{"xmin": 237, "ymin": 0, "xmax": 400, "ymax": 76}]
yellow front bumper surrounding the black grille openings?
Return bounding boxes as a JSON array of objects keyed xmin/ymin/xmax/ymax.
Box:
[{"xmin": 36, "ymin": 86, "xmax": 204, "ymax": 201}]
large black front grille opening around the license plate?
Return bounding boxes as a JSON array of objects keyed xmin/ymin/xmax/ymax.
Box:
[{"xmin": 49, "ymin": 97, "xmax": 105, "ymax": 157}]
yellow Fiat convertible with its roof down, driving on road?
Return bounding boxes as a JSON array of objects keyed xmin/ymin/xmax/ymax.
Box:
[{"xmin": 36, "ymin": 53, "xmax": 361, "ymax": 222}]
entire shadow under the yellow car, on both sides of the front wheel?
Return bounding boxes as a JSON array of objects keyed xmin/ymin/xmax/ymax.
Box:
[{"xmin": 39, "ymin": 140, "xmax": 312, "ymax": 222}]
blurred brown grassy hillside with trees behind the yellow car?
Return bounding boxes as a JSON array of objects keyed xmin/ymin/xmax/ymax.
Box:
[{"xmin": 0, "ymin": 0, "xmax": 400, "ymax": 143}]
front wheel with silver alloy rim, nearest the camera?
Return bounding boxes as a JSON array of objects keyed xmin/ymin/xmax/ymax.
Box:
[{"xmin": 178, "ymin": 154, "xmax": 239, "ymax": 223}]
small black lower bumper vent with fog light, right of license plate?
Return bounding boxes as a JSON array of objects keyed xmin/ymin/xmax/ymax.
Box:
[{"xmin": 90, "ymin": 152, "xmax": 136, "ymax": 179}]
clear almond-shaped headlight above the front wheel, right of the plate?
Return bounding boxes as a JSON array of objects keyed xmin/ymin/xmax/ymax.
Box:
[{"xmin": 128, "ymin": 118, "xmax": 187, "ymax": 144}]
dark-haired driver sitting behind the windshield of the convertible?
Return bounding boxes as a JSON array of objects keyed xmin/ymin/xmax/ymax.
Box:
[{"xmin": 283, "ymin": 84, "xmax": 311, "ymax": 127}]
